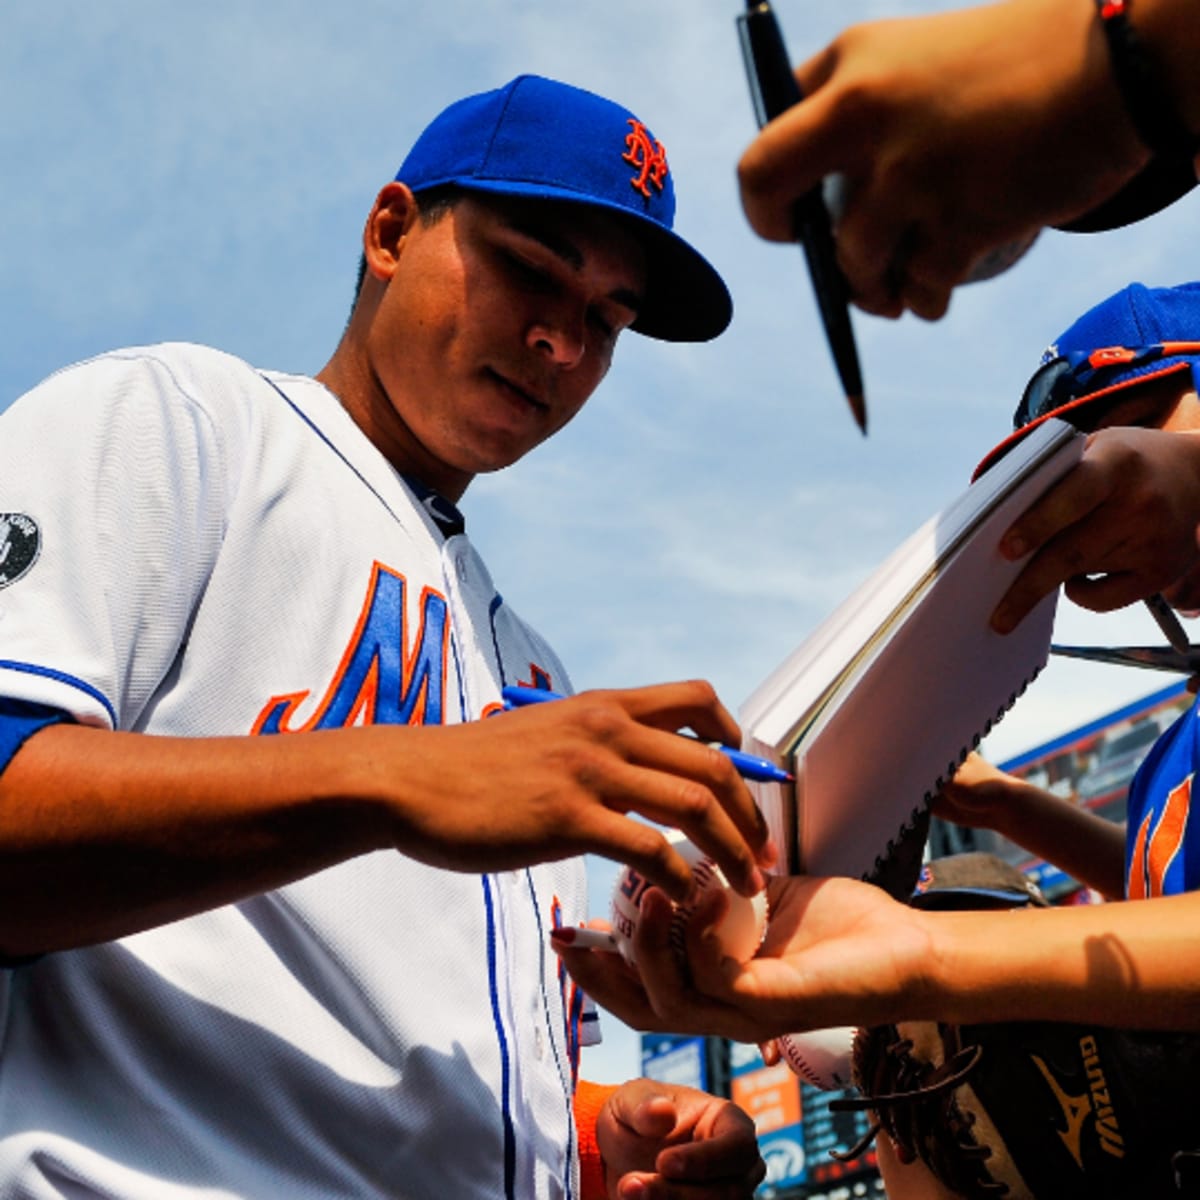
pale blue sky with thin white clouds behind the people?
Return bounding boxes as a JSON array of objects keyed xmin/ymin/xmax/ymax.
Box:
[{"xmin": 0, "ymin": 0, "xmax": 1200, "ymax": 1079}]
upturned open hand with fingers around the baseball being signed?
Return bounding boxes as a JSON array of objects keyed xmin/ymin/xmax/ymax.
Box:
[{"xmin": 556, "ymin": 876, "xmax": 930, "ymax": 1043}]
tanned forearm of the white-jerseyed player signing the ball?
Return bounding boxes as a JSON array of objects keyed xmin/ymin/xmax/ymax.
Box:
[{"xmin": 0, "ymin": 725, "xmax": 385, "ymax": 955}]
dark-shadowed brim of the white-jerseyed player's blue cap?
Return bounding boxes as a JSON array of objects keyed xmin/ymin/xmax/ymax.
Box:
[{"xmin": 412, "ymin": 176, "xmax": 733, "ymax": 342}]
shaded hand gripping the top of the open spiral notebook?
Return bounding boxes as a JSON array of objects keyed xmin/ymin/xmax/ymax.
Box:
[{"xmin": 991, "ymin": 427, "xmax": 1200, "ymax": 634}]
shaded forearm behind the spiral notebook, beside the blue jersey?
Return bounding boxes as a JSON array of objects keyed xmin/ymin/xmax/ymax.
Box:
[{"xmin": 996, "ymin": 780, "xmax": 1124, "ymax": 899}]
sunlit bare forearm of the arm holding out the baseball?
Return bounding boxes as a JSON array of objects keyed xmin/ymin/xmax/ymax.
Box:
[{"xmin": 931, "ymin": 893, "xmax": 1200, "ymax": 1030}]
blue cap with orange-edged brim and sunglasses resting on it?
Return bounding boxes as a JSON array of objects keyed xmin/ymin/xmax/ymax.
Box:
[{"xmin": 974, "ymin": 283, "xmax": 1200, "ymax": 478}]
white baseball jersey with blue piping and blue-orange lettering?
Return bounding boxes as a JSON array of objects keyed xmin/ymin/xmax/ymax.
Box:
[{"xmin": 0, "ymin": 346, "xmax": 594, "ymax": 1200}]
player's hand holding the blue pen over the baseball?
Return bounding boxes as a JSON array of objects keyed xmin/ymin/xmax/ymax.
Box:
[{"xmin": 377, "ymin": 682, "xmax": 774, "ymax": 900}]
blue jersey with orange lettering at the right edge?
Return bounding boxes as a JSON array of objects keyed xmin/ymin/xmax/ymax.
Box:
[{"xmin": 1126, "ymin": 701, "xmax": 1200, "ymax": 900}]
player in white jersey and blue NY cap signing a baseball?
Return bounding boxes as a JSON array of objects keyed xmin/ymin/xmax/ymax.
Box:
[{"xmin": 0, "ymin": 76, "xmax": 772, "ymax": 1200}]
